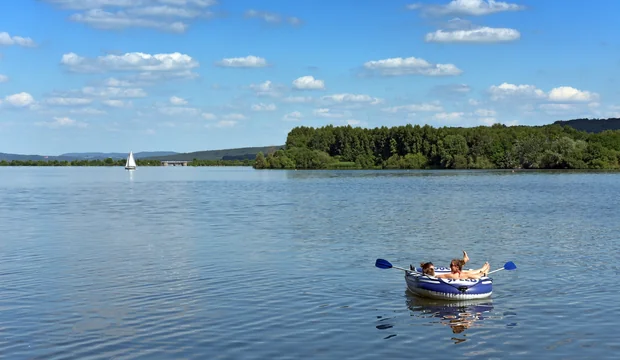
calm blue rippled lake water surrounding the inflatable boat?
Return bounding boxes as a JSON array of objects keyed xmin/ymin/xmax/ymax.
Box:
[{"xmin": 0, "ymin": 167, "xmax": 620, "ymax": 360}]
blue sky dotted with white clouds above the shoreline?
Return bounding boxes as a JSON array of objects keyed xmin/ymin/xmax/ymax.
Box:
[{"xmin": 0, "ymin": 0, "xmax": 620, "ymax": 155}]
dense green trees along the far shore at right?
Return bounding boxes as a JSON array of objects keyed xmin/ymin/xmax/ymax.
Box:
[{"xmin": 253, "ymin": 124, "xmax": 620, "ymax": 169}]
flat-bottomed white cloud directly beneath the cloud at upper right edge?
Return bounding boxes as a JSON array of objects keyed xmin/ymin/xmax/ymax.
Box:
[{"xmin": 425, "ymin": 27, "xmax": 521, "ymax": 43}]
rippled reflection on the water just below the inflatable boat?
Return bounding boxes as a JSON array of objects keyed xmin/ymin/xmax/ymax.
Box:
[{"xmin": 406, "ymin": 291, "xmax": 493, "ymax": 344}]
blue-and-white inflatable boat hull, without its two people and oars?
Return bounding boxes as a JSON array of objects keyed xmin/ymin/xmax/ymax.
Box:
[{"xmin": 405, "ymin": 267, "xmax": 493, "ymax": 300}]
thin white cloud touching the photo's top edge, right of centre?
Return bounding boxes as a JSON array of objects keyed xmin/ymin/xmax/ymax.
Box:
[{"xmin": 407, "ymin": 0, "xmax": 525, "ymax": 16}]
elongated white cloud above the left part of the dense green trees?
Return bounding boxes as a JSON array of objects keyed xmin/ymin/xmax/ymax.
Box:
[{"xmin": 364, "ymin": 57, "xmax": 463, "ymax": 76}]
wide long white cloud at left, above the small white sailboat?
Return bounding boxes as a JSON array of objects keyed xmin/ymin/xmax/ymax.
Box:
[{"xmin": 60, "ymin": 52, "xmax": 199, "ymax": 73}]
